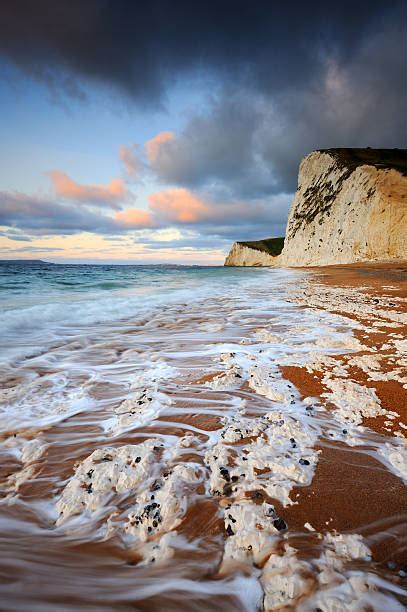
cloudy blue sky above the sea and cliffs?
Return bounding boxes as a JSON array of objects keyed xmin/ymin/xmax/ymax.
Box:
[{"xmin": 0, "ymin": 0, "xmax": 407, "ymax": 265}]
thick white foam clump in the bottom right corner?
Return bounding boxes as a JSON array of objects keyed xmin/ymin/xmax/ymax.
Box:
[{"xmin": 261, "ymin": 533, "xmax": 403, "ymax": 612}]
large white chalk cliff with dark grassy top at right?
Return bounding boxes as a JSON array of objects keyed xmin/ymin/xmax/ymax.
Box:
[{"xmin": 279, "ymin": 149, "xmax": 407, "ymax": 266}]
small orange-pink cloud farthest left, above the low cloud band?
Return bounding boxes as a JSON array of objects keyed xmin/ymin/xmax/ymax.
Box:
[{"xmin": 47, "ymin": 170, "xmax": 127, "ymax": 209}]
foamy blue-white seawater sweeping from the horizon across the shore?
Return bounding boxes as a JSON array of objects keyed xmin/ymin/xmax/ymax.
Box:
[{"xmin": 0, "ymin": 264, "xmax": 404, "ymax": 610}]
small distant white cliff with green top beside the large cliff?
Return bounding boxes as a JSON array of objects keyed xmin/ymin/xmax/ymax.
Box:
[{"xmin": 225, "ymin": 238, "xmax": 284, "ymax": 266}]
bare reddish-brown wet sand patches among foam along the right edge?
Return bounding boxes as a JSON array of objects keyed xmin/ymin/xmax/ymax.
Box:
[{"xmin": 282, "ymin": 263, "xmax": 407, "ymax": 568}]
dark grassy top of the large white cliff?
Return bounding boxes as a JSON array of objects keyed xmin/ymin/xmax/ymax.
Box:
[{"xmin": 318, "ymin": 147, "xmax": 407, "ymax": 176}]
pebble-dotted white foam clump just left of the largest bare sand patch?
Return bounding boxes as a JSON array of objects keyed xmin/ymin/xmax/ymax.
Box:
[{"xmin": 205, "ymin": 411, "xmax": 318, "ymax": 505}]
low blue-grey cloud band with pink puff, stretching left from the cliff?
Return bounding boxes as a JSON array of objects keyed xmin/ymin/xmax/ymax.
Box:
[{"xmin": 0, "ymin": 182, "xmax": 291, "ymax": 242}]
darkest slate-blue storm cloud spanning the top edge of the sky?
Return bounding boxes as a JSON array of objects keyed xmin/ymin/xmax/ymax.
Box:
[{"xmin": 0, "ymin": 0, "xmax": 405, "ymax": 102}]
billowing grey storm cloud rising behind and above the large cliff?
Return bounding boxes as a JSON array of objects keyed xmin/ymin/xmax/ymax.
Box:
[{"xmin": 151, "ymin": 22, "xmax": 407, "ymax": 199}]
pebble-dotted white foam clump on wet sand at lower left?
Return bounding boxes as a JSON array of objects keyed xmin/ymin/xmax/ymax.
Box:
[{"xmin": 56, "ymin": 439, "xmax": 202, "ymax": 564}]
